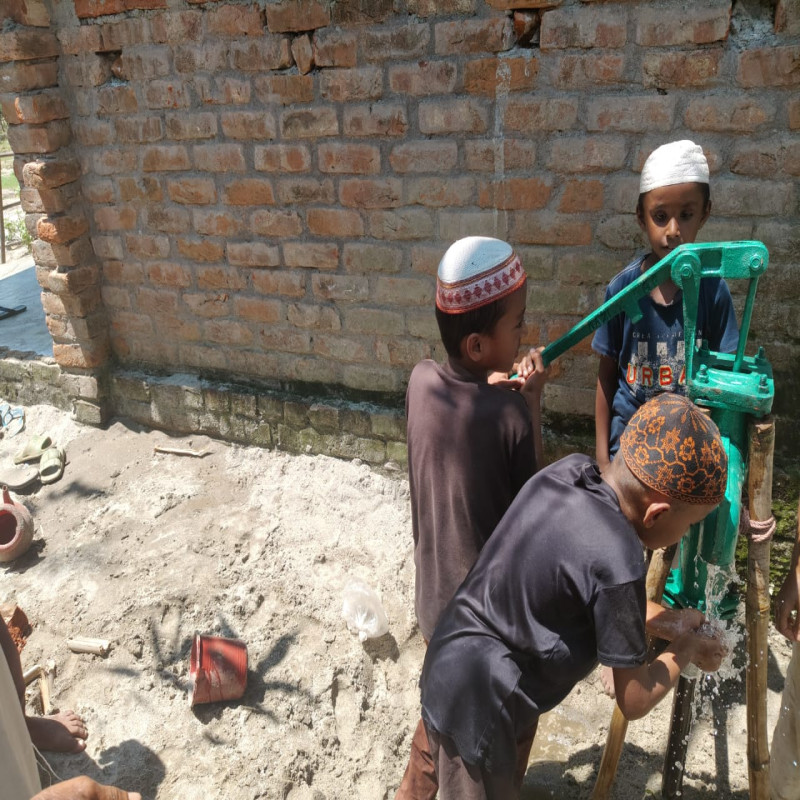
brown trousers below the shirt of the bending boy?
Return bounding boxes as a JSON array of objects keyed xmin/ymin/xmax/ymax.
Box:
[{"xmin": 426, "ymin": 728, "xmax": 519, "ymax": 800}]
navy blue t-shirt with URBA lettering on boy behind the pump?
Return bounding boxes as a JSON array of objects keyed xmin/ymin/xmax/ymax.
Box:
[{"xmin": 592, "ymin": 254, "xmax": 739, "ymax": 455}]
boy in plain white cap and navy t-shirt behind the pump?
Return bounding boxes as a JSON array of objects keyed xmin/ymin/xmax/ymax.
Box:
[{"xmin": 592, "ymin": 140, "xmax": 739, "ymax": 469}]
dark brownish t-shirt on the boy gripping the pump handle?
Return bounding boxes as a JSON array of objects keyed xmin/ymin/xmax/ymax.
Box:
[{"xmin": 406, "ymin": 360, "xmax": 535, "ymax": 639}]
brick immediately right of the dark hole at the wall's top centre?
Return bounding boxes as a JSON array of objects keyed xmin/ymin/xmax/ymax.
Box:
[{"xmin": 539, "ymin": 5, "xmax": 628, "ymax": 50}]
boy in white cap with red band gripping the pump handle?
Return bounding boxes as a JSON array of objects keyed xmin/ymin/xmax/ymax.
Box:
[{"xmin": 397, "ymin": 236, "xmax": 545, "ymax": 800}]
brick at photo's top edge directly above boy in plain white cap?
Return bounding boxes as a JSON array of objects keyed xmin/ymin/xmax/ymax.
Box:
[{"xmin": 636, "ymin": 0, "xmax": 731, "ymax": 47}]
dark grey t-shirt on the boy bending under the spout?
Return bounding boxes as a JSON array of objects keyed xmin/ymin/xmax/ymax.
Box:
[{"xmin": 420, "ymin": 455, "xmax": 646, "ymax": 771}]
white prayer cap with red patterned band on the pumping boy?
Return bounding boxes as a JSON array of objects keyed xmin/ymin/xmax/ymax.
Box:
[{"xmin": 436, "ymin": 236, "xmax": 526, "ymax": 314}]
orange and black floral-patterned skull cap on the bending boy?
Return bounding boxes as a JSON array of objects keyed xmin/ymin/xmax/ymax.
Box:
[{"xmin": 620, "ymin": 393, "xmax": 728, "ymax": 505}]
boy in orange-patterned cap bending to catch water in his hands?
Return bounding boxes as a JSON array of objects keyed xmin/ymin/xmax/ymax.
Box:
[{"xmin": 420, "ymin": 394, "xmax": 727, "ymax": 800}]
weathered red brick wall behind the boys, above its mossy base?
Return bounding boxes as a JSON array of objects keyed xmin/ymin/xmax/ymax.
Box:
[{"xmin": 0, "ymin": 0, "xmax": 800, "ymax": 456}]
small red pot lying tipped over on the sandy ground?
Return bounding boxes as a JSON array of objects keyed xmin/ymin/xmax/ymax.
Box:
[{"xmin": 189, "ymin": 633, "xmax": 247, "ymax": 706}]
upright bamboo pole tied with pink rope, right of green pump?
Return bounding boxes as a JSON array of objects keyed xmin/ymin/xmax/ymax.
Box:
[{"xmin": 745, "ymin": 417, "xmax": 775, "ymax": 800}]
